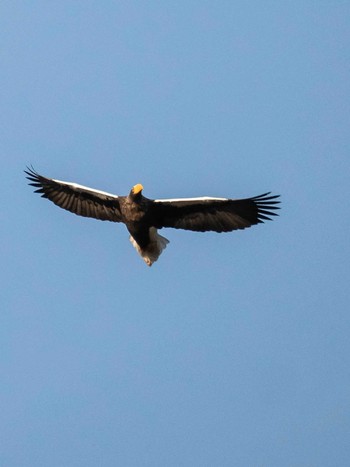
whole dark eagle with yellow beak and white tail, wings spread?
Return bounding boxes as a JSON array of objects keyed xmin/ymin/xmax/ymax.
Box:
[{"xmin": 25, "ymin": 167, "xmax": 279, "ymax": 266}]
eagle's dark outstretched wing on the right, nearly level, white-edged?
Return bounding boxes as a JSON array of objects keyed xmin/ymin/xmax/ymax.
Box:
[{"xmin": 152, "ymin": 193, "xmax": 279, "ymax": 232}]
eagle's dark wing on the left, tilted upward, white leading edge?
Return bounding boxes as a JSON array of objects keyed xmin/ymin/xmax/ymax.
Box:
[{"xmin": 25, "ymin": 168, "xmax": 122, "ymax": 222}]
